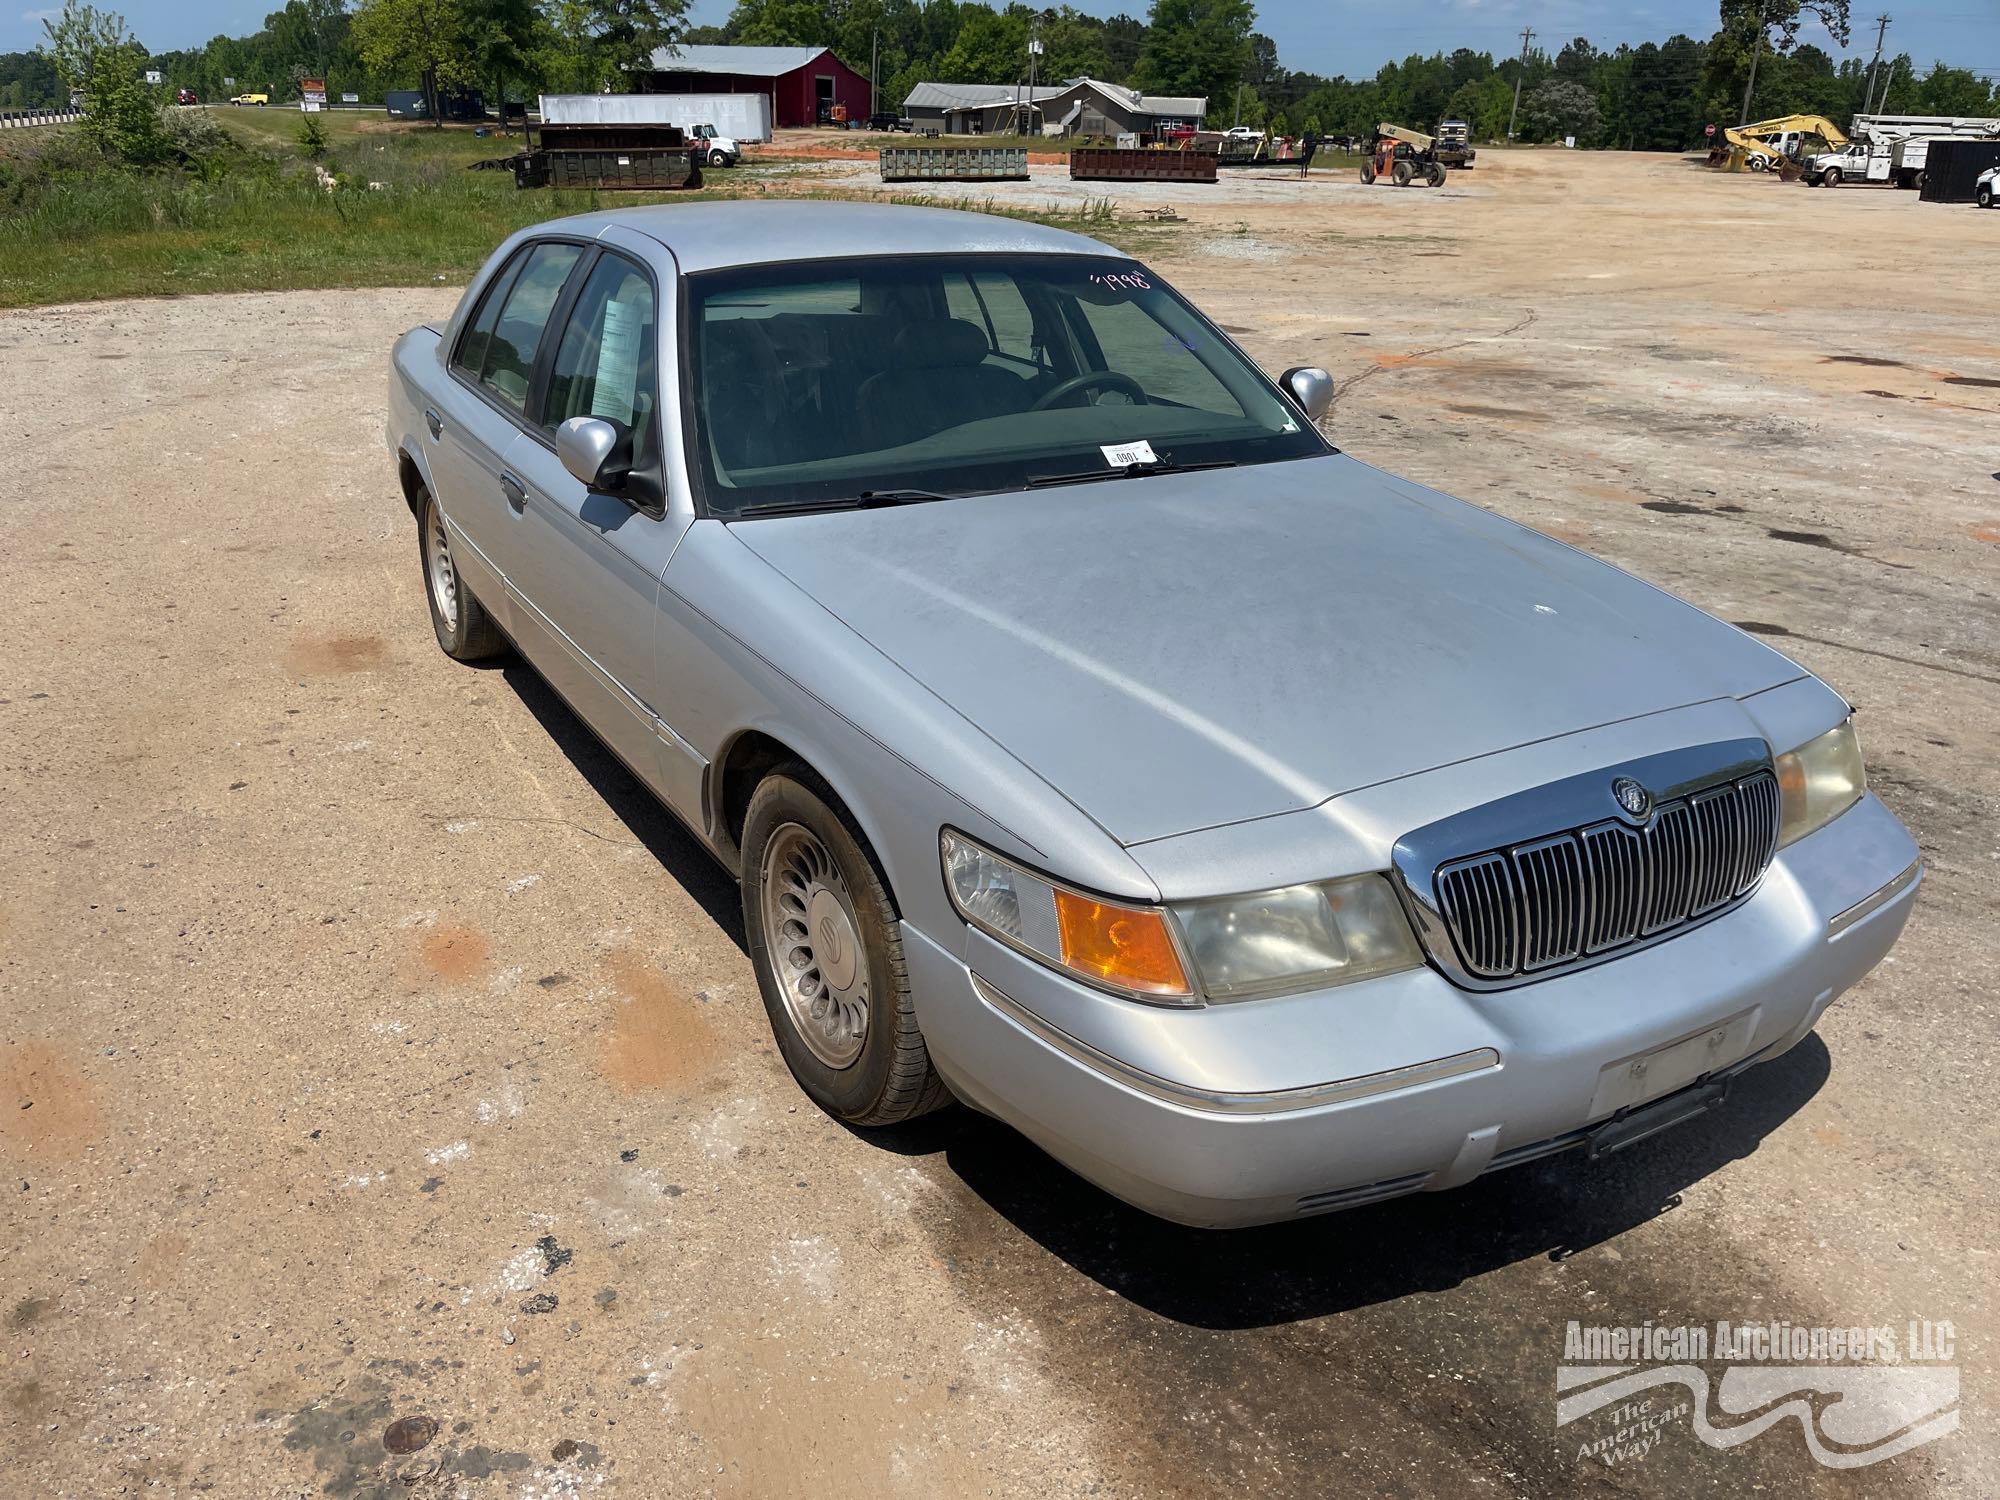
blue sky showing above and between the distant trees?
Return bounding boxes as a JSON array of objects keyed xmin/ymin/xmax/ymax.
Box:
[{"xmin": 0, "ymin": 0, "xmax": 2000, "ymax": 78}]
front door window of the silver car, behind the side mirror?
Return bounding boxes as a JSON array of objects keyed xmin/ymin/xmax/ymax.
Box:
[{"xmin": 542, "ymin": 254, "xmax": 660, "ymax": 468}]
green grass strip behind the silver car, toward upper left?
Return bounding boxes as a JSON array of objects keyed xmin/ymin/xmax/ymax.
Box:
[{"xmin": 0, "ymin": 108, "xmax": 1162, "ymax": 308}]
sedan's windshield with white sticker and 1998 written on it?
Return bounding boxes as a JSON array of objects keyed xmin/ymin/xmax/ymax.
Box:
[{"xmin": 686, "ymin": 254, "xmax": 1328, "ymax": 514}]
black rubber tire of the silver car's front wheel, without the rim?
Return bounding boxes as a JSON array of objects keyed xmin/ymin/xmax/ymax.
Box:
[{"xmin": 742, "ymin": 776, "xmax": 952, "ymax": 1126}]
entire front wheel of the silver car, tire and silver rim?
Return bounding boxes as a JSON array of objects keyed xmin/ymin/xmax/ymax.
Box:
[{"xmin": 742, "ymin": 764, "xmax": 950, "ymax": 1126}]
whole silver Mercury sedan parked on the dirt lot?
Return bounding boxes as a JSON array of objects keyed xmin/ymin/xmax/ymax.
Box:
[{"xmin": 386, "ymin": 202, "xmax": 1922, "ymax": 1226}]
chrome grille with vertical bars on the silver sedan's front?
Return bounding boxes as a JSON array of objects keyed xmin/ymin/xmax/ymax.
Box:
[{"xmin": 1436, "ymin": 770, "xmax": 1778, "ymax": 980}]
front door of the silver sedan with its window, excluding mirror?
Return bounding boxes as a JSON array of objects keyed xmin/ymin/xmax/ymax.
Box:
[{"xmin": 506, "ymin": 250, "xmax": 700, "ymax": 816}]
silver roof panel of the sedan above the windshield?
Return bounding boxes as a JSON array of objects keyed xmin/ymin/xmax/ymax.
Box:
[{"xmin": 536, "ymin": 198, "xmax": 1128, "ymax": 272}]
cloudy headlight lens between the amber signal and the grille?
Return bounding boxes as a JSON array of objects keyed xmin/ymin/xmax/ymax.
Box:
[{"xmin": 1174, "ymin": 874, "xmax": 1422, "ymax": 1000}]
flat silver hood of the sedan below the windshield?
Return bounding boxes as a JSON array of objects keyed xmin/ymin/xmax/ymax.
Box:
[{"xmin": 730, "ymin": 454, "xmax": 1802, "ymax": 846}]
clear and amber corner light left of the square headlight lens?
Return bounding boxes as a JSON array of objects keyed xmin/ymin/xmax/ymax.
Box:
[{"xmin": 940, "ymin": 832, "xmax": 1194, "ymax": 1004}]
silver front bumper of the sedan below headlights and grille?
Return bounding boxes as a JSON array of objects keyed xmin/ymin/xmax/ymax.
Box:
[{"xmin": 904, "ymin": 794, "xmax": 1922, "ymax": 1226}]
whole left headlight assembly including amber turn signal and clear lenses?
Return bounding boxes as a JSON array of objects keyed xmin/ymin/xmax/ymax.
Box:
[{"xmin": 942, "ymin": 832, "xmax": 1422, "ymax": 1004}]
